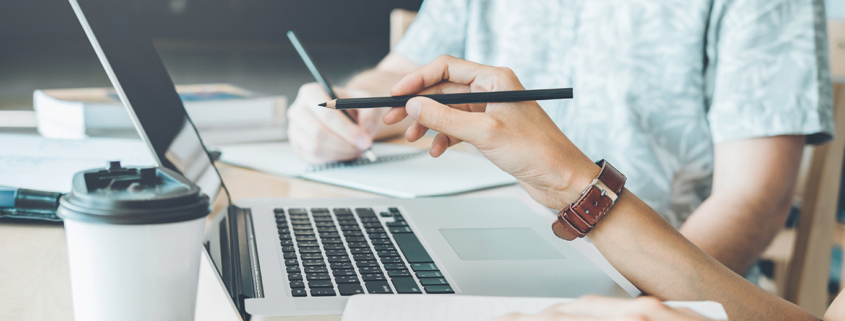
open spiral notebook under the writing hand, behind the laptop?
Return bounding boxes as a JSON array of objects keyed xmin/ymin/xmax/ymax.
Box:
[{"xmin": 219, "ymin": 142, "xmax": 516, "ymax": 198}]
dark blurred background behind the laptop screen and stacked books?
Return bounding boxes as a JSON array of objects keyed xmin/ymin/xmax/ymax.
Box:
[{"xmin": 0, "ymin": 0, "xmax": 422, "ymax": 110}]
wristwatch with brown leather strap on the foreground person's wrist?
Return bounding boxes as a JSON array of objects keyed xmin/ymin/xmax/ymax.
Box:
[{"xmin": 552, "ymin": 159, "xmax": 625, "ymax": 241}]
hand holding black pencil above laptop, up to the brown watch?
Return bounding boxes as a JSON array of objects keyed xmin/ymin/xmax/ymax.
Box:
[{"xmin": 383, "ymin": 56, "xmax": 598, "ymax": 208}]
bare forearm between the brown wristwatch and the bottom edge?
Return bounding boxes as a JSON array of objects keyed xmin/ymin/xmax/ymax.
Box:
[{"xmin": 590, "ymin": 191, "xmax": 817, "ymax": 320}]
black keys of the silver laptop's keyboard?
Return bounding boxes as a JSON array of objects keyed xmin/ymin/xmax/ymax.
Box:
[{"xmin": 273, "ymin": 207, "xmax": 455, "ymax": 297}]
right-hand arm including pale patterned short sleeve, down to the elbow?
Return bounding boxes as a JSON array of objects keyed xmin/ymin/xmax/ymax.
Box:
[{"xmin": 692, "ymin": 0, "xmax": 832, "ymax": 274}]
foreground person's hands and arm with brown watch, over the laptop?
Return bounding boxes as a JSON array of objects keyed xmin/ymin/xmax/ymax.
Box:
[{"xmin": 383, "ymin": 56, "xmax": 832, "ymax": 321}]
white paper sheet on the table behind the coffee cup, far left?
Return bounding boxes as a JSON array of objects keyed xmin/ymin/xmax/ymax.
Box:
[{"xmin": 0, "ymin": 134, "xmax": 155, "ymax": 193}]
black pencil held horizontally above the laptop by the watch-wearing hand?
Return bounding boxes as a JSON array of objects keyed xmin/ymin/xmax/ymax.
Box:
[{"xmin": 320, "ymin": 88, "xmax": 572, "ymax": 110}]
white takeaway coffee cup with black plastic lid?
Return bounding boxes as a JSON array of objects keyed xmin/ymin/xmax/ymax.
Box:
[{"xmin": 58, "ymin": 163, "xmax": 210, "ymax": 321}]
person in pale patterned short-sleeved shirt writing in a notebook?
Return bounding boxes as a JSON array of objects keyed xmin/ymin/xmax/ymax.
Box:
[{"xmin": 288, "ymin": 0, "xmax": 832, "ymax": 274}]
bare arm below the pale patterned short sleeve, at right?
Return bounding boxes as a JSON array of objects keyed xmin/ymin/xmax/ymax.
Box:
[{"xmin": 680, "ymin": 136, "xmax": 806, "ymax": 275}]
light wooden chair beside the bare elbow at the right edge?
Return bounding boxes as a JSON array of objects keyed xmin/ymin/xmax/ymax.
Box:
[{"xmin": 762, "ymin": 83, "xmax": 845, "ymax": 317}]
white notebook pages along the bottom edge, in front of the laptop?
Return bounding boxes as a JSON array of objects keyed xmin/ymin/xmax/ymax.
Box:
[{"xmin": 340, "ymin": 295, "xmax": 728, "ymax": 321}]
